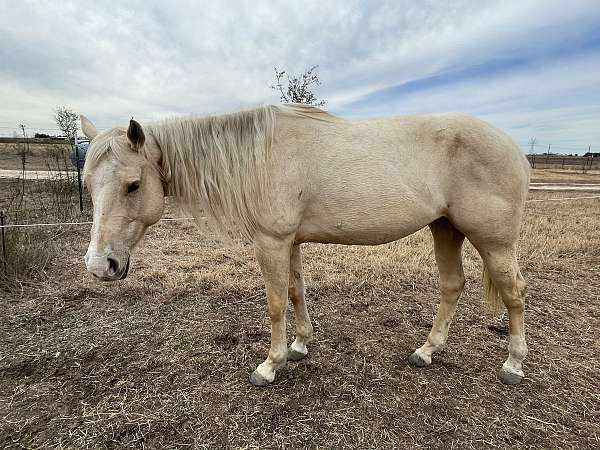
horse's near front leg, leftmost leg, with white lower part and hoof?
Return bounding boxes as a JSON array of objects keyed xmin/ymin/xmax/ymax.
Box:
[{"xmin": 250, "ymin": 236, "xmax": 293, "ymax": 386}]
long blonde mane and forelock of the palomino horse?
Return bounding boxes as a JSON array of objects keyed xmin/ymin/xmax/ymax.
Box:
[{"xmin": 84, "ymin": 104, "xmax": 339, "ymax": 240}]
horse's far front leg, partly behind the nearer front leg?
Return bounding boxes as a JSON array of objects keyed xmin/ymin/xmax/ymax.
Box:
[{"xmin": 288, "ymin": 245, "xmax": 313, "ymax": 361}]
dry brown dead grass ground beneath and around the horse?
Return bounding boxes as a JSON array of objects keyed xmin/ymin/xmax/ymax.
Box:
[{"xmin": 0, "ymin": 174, "xmax": 600, "ymax": 449}]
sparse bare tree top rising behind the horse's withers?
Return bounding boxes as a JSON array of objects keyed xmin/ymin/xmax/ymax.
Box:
[{"xmin": 271, "ymin": 66, "xmax": 325, "ymax": 106}]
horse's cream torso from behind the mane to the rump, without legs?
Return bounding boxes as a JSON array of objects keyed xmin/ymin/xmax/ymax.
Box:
[{"xmin": 264, "ymin": 113, "xmax": 528, "ymax": 244}]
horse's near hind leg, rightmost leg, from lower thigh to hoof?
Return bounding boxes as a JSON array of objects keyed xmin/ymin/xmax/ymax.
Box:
[{"xmin": 477, "ymin": 245, "xmax": 527, "ymax": 384}]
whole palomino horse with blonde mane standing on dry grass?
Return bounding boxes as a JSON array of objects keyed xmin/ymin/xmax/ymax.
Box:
[{"xmin": 81, "ymin": 105, "xmax": 529, "ymax": 385}]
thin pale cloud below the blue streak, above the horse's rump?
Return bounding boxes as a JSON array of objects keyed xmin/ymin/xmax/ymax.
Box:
[{"xmin": 342, "ymin": 49, "xmax": 600, "ymax": 153}]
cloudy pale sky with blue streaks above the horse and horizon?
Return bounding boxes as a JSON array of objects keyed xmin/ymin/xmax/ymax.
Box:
[{"xmin": 0, "ymin": 0, "xmax": 600, "ymax": 154}]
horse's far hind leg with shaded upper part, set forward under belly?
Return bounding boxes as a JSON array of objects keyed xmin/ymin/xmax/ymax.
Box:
[{"xmin": 408, "ymin": 218, "xmax": 465, "ymax": 367}]
